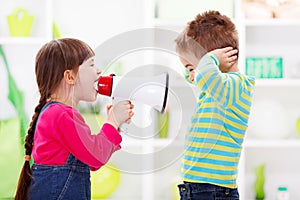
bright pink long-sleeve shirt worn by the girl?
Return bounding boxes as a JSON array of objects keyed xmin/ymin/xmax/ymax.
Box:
[{"xmin": 32, "ymin": 103, "xmax": 122, "ymax": 170}]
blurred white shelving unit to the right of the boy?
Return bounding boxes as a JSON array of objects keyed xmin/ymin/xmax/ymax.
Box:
[{"xmin": 237, "ymin": 1, "xmax": 300, "ymax": 200}]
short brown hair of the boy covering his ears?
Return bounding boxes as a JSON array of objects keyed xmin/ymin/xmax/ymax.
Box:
[{"xmin": 175, "ymin": 11, "xmax": 239, "ymax": 59}]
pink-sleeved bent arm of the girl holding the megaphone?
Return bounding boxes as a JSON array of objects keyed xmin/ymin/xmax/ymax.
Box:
[{"xmin": 58, "ymin": 110, "xmax": 122, "ymax": 170}]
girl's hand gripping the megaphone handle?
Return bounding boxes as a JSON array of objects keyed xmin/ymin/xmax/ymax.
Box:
[{"xmin": 107, "ymin": 100, "xmax": 134, "ymax": 130}]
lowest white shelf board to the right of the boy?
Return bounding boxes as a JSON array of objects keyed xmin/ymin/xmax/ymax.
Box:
[{"xmin": 244, "ymin": 139, "xmax": 300, "ymax": 148}]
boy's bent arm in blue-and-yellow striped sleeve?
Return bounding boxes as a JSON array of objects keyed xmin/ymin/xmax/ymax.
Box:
[{"xmin": 194, "ymin": 50, "xmax": 240, "ymax": 107}]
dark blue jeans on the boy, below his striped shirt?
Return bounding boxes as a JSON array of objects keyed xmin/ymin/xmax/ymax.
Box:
[{"xmin": 178, "ymin": 182, "xmax": 239, "ymax": 200}]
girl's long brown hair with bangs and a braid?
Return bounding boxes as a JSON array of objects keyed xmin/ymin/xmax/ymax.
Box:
[{"xmin": 15, "ymin": 38, "xmax": 95, "ymax": 200}]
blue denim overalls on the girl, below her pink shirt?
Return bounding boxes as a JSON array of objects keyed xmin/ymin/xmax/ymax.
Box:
[{"xmin": 28, "ymin": 154, "xmax": 91, "ymax": 200}]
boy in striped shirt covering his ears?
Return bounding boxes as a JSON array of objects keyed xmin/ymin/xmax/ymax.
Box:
[{"xmin": 175, "ymin": 11, "xmax": 254, "ymax": 200}]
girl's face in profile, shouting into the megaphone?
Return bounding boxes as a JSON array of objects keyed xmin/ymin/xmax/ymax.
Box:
[{"xmin": 74, "ymin": 57, "xmax": 100, "ymax": 101}]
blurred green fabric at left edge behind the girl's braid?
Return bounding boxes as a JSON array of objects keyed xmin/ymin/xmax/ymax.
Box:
[{"xmin": 0, "ymin": 45, "xmax": 28, "ymax": 199}]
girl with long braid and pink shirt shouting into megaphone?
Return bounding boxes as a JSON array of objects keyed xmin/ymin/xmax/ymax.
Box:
[{"xmin": 15, "ymin": 38, "xmax": 133, "ymax": 200}]
